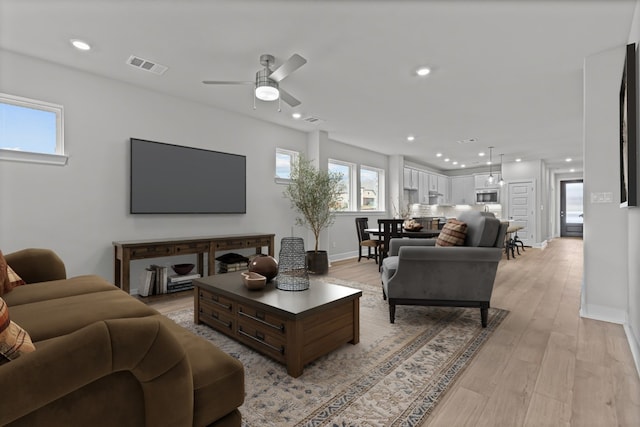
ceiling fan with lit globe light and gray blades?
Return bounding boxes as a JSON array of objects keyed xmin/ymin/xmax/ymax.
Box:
[{"xmin": 202, "ymin": 53, "xmax": 307, "ymax": 107}]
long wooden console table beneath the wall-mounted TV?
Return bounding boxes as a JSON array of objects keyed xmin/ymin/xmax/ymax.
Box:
[{"xmin": 113, "ymin": 233, "xmax": 275, "ymax": 292}]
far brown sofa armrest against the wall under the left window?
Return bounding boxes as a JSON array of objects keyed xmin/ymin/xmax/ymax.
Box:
[{"xmin": 4, "ymin": 248, "xmax": 67, "ymax": 283}]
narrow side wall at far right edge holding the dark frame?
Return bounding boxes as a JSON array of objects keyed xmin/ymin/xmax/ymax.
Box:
[{"xmin": 626, "ymin": 1, "xmax": 640, "ymax": 373}]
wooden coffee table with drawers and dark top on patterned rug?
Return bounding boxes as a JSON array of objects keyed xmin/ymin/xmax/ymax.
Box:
[{"xmin": 193, "ymin": 273, "xmax": 362, "ymax": 377}]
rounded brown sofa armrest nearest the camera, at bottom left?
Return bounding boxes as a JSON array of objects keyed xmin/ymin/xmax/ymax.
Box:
[{"xmin": 0, "ymin": 317, "xmax": 193, "ymax": 426}]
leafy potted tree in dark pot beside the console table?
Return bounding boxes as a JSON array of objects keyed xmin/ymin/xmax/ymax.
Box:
[{"xmin": 284, "ymin": 157, "xmax": 343, "ymax": 274}]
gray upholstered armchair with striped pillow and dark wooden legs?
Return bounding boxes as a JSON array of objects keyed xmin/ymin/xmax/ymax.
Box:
[{"xmin": 382, "ymin": 211, "xmax": 508, "ymax": 327}]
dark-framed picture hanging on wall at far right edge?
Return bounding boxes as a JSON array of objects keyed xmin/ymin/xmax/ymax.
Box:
[{"xmin": 620, "ymin": 43, "xmax": 640, "ymax": 207}]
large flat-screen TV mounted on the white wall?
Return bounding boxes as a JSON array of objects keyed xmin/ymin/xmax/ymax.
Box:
[{"xmin": 130, "ymin": 138, "xmax": 247, "ymax": 214}]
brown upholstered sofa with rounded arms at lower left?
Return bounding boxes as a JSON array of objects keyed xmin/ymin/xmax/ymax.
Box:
[{"xmin": 0, "ymin": 249, "xmax": 244, "ymax": 427}]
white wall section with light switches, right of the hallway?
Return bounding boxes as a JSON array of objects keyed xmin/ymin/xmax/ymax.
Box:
[{"xmin": 581, "ymin": 46, "xmax": 630, "ymax": 323}]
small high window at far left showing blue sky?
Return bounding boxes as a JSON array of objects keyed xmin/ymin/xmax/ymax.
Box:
[{"xmin": 0, "ymin": 93, "xmax": 67, "ymax": 164}]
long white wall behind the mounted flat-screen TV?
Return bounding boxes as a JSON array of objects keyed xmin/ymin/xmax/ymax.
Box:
[{"xmin": 0, "ymin": 51, "xmax": 310, "ymax": 288}]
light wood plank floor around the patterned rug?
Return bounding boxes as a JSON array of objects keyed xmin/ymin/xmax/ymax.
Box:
[{"xmin": 145, "ymin": 239, "xmax": 640, "ymax": 427}]
